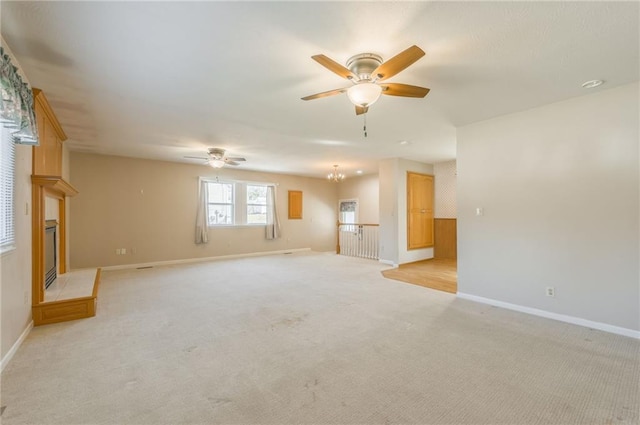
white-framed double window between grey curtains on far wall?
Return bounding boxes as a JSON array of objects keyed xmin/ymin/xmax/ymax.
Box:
[{"xmin": 207, "ymin": 181, "xmax": 267, "ymax": 226}]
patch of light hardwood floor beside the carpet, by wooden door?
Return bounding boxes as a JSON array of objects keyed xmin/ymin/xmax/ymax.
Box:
[{"xmin": 382, "ymin": 258, "xmax": 458, "ymax": 294}]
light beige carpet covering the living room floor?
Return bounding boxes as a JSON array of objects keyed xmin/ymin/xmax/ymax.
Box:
[{"xmin": 2, "ymin": 253, "xmax": 640, "ymax": 425}]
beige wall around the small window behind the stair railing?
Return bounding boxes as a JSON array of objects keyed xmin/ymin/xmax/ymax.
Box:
[{"xmin": 336, "ymin": 174, "xmax": 380, "ymax": 224}]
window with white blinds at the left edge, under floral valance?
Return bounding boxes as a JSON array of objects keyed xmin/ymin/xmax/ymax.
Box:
[{"xmin": 0, "ymin": 126, "xmax": 16, "ymax": 252}]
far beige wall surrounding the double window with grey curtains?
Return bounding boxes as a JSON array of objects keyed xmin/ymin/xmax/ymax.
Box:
[{"xmin": 70, "ymin": 152, "xmax": 338, "ymax": 269}]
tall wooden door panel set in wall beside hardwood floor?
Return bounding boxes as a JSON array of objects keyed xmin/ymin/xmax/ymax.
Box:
[{"xmin": 407, "ymin": 172, "xmax": 433, "ymax": 249}]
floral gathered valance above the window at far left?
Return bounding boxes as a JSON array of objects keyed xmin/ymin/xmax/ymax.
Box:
[{"xmin": 0, "ymin": 46, "xmax": 38, "ymax": 145}]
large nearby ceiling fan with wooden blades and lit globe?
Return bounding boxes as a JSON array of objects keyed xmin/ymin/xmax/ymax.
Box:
[{"xmin": 302, "ymin": 45, "xmax": 429, "ymax": 115}]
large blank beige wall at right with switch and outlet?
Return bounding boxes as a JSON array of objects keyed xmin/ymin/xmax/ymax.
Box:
[{"xmin": 458, "ymin": 83, "xmax": 640, "ymax": 335}]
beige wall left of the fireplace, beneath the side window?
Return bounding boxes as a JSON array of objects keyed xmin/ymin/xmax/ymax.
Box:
[{"xmin": 0, "ymin": 40, "xmax": 32, "ymax": 367}]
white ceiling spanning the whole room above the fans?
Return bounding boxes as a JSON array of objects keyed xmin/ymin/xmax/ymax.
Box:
[{"xmin": 0, "ymin": 1, "xmax": 640, "ymax": 176}]
